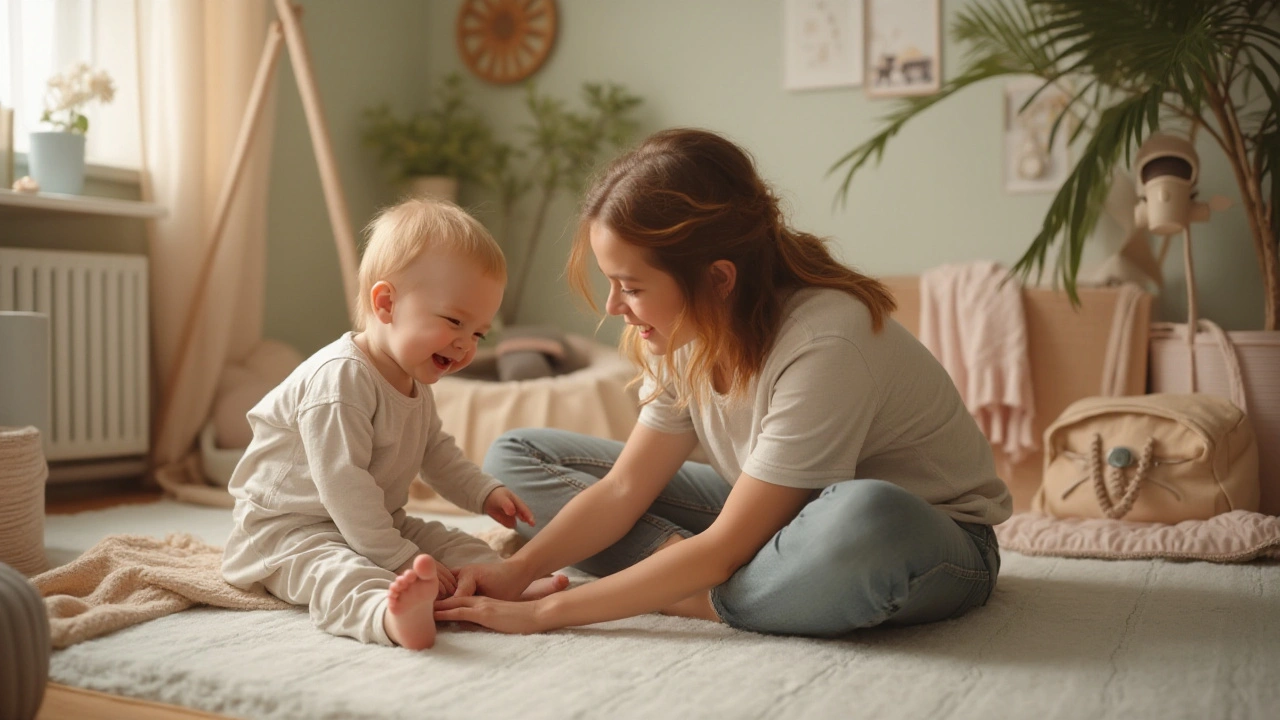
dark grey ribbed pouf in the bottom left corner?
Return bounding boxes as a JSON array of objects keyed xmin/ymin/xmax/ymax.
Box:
[{"xmin": 0, "ymin": 562, "xmax": 51, "ymax": 720}]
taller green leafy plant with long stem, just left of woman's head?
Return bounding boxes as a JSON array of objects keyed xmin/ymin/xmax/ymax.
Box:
[{"xmin": 480, "ymin": 82, "xmax": 643, "ymax": 325}]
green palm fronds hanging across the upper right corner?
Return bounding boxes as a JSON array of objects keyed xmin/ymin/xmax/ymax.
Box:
[{"xmin": 831, "ymin": 0, "xmax": 1280, "ymax": 331}]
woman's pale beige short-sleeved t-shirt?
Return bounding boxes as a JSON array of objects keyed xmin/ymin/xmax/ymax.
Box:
[{"xmin": 640, "ymin": 288, "xmax": 1012, "ymax": 524}]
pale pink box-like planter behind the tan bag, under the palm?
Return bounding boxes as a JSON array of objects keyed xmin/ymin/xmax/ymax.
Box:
[{"xmin": 1149, "ymin": 323, "xmax": 1280, "ymax": 515}]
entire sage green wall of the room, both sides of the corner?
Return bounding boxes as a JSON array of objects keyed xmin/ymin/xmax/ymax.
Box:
[{"xmin": 0, "ymin": 0, "xmax": 1262, "ymax": 352}]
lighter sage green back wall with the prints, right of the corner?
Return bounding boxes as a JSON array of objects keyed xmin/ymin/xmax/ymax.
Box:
[{"xmin": 409, "ymin": 0, "xmax": 1262, "ymax": 328}]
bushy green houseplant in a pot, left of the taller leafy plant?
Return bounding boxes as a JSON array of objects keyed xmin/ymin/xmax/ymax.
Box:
[{"xmin": 364, "ymin": 73, "xmax": 494, "ymax": 182}]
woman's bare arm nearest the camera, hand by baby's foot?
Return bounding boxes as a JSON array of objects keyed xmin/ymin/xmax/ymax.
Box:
[{"xmin": 435, "ymin": 475, "xmax": 812, "ymax": 633}]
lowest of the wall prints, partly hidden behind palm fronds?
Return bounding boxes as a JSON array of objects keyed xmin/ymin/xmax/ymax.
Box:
[{"xmin": 1004, "ymin": 77, "xmax": 1075, "ymax": 192}]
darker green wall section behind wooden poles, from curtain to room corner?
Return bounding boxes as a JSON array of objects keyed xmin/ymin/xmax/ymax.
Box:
[{"xmin": 264, "ymin": 0, "xmax": 434, "ymax": 354}]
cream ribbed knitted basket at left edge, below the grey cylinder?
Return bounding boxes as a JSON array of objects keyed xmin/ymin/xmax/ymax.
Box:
[{"xmin": 0, "ymin": 427, "xmax": 49, "ymax": 575}]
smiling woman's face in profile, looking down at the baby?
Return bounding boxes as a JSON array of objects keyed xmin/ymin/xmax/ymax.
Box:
[{"xmin": 590, "ymin": 222, "xmax": 694, "ymax": 355}]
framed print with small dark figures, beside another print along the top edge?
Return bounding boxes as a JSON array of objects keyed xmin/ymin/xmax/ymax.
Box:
[{"xmin": 863, "ymin": 0, "xmax": 942, "ymax": 97}]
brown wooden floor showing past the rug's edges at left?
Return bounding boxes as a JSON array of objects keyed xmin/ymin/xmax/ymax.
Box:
[{"xmin": 36, "ymin": 482, "xmax": 235, "ymax": 720}]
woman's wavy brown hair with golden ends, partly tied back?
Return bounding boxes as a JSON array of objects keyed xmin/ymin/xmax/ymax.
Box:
[{"xmin": 567, "ymin": 128, "xmax": 896, "ymax": 405}]
